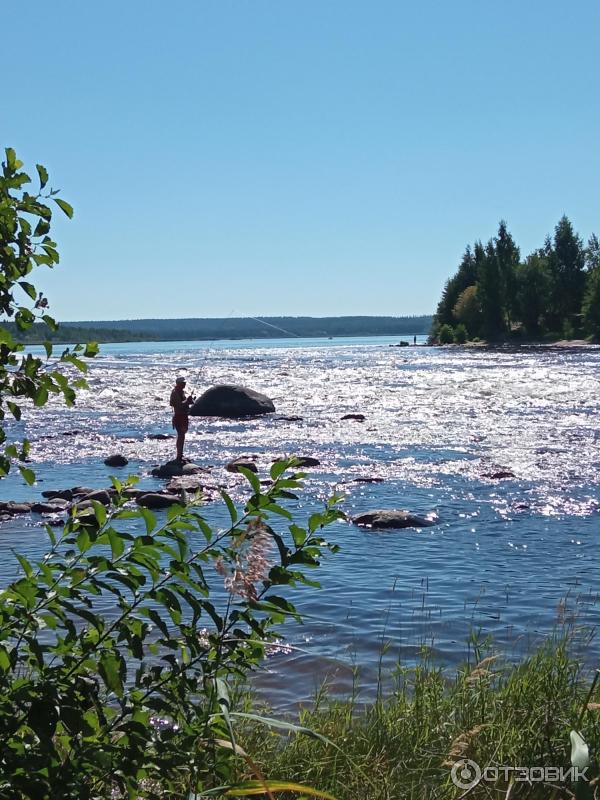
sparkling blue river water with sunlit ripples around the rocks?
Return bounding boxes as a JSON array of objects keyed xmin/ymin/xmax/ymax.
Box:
[{"xmin": 0, "ymin": 339, "xmax": 600, "ymax": 704}]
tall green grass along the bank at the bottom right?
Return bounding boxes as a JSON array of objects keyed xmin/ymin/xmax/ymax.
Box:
[{"xmin": 241, "ymin": 639, "xmax": 600, "ymax": 800}]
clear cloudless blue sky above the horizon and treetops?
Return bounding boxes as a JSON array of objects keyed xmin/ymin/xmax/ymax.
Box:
[{"xmin": 0, "ymin": 0, "xmax": 600, "ymax": 320}]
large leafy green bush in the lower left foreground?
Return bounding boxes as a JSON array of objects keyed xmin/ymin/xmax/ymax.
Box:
[{"xmin": 0, "ymin": 468, "xmax": 343, "ymax": 800}]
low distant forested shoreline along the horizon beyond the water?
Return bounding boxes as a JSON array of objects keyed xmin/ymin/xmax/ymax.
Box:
[{"xmin": 2, "ymin": 315, "xmax": 433, "ymax": 344}]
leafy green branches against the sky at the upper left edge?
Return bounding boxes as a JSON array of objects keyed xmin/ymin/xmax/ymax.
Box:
[{"xmin": 0, "ymin": 147, "xmax": 96, "ymax": 483}]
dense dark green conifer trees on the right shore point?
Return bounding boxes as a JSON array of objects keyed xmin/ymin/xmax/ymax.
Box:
[{"xmin": 432, "ymin": 216, "xmax": 600, "ymax": 344}]
